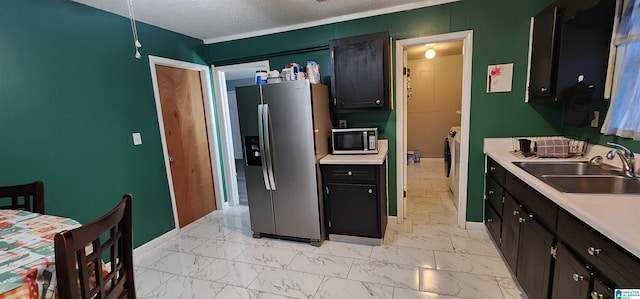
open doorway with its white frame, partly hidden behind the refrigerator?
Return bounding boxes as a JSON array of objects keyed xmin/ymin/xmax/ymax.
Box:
[{"xmin": 211, "ymin": 60, "xmax": 270, "ymax": 205}]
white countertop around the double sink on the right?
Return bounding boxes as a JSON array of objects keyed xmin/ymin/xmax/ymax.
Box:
[{"xmin": 484, "ymin": 138, "xmax": 640, "ymax": 257}]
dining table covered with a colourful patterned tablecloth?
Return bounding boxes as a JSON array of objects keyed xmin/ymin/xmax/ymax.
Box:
[{"xmin": 0, "ymin": 210, "xmax": 81, "ymax": 299}]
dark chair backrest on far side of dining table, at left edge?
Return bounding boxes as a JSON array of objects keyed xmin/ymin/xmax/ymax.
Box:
[{"xmin": 0, "ymin": 181, "xmax": 44, "ymax": 214}]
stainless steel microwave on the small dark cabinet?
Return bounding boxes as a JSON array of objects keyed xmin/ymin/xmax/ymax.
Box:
[{"xmin": 331, "ymin": 128, "xmax": 378, "ymax": 155}]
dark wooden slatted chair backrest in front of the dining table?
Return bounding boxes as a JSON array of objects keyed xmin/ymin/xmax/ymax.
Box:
[{"xmin": 54, "ymin": 194, "xmax": 136, "ymax": 299}]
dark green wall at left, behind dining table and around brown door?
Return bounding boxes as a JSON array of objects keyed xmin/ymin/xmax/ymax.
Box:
[{"xmin": 0, "ymin": 0, "xmax": 206, "ymax": 245}]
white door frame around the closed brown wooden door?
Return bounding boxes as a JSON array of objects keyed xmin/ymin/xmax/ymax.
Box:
[{"xmin": 149, "ymin": 55, "xmax": 228, "ymax": 228}]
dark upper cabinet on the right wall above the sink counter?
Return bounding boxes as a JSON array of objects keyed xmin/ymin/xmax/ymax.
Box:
[{"xmin": 528, "ymin": 0, "xmax": 616, "ymax": 102}]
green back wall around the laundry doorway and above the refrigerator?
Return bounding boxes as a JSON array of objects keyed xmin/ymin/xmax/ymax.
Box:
[{"xmin": 205, "ymin": 0, "xmax": 561, "ymax": 221}]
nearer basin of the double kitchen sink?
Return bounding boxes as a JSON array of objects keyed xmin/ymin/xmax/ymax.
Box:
[{"xmin": 539, "ymin": 175, "xmax": 640, "ymax": 194}]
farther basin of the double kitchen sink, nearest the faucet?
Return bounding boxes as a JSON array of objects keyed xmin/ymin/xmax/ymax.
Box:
[{"xmin": 513, "ymin": 161, "xmax": 612, "ymax": 176}]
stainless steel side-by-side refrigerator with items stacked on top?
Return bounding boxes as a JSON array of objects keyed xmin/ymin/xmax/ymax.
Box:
[{"xmin": 236, "ymin": 80, "xmax": 331, "ymax": 246}]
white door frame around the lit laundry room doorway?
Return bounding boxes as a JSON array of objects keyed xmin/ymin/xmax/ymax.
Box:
[{"xmin": 395, "ymin": 30, "xmax": 473, "ymax": 229}]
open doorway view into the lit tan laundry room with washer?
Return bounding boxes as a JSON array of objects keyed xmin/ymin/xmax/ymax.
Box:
[{"xmin": 406, "ymin": 40, "xmax": 463, "ymax": 220}]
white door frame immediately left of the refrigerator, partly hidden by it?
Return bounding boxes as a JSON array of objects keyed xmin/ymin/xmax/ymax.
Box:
[{"xmin": 211, "ymin": 60, "xmax": 271, "ymax": 206}]
